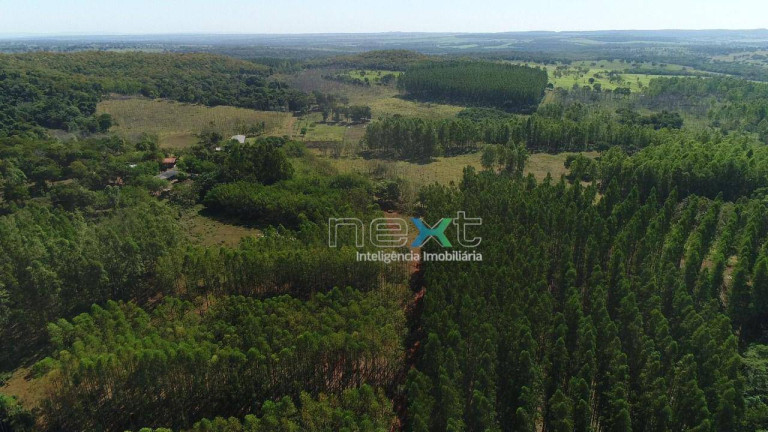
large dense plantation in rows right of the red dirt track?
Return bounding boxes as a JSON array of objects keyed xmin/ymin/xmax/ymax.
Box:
[{"xmin": 408, "ymin": 159, "xmax": 768, "ymax": 431}]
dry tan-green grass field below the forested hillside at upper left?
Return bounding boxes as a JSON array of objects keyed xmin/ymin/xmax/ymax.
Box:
[{"xmin": 97, "ymin": 98, "xmax": 295, "ymax": 148}]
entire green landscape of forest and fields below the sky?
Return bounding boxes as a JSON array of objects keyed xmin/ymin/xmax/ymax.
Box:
[{"xmin": 0, "ymin": 37, "xmax": 768, "ymax": 432}]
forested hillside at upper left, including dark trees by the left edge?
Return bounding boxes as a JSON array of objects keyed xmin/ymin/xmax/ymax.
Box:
[{"xmin": 0, "ymin": 52, "xmax": 309, "ymax": 136}]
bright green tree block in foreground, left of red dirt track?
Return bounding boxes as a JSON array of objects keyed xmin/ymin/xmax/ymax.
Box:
[{"xmin": 40, "ymin": 290, "xmax": 405, "ymax": 430}]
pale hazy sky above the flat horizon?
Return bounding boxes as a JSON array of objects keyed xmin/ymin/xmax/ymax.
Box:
[{"xmin": 0, "ymin": 0, "xmax": 768, "ymax": 34}]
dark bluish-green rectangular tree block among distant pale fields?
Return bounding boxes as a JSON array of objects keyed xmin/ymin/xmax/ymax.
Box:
[{"xmin": 398, "ymin": 61, "xmax": 547, "ymax": 111}]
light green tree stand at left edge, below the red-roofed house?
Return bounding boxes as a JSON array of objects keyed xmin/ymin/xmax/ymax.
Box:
[{"xmin": 0, "ymin": 194, "xmax": 180, "ymax": 364}]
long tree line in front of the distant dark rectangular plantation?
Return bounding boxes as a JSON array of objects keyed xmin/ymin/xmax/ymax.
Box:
[{"xmin": 362, "ymin": 103, "xmax": 682, "ymax": 160}]
